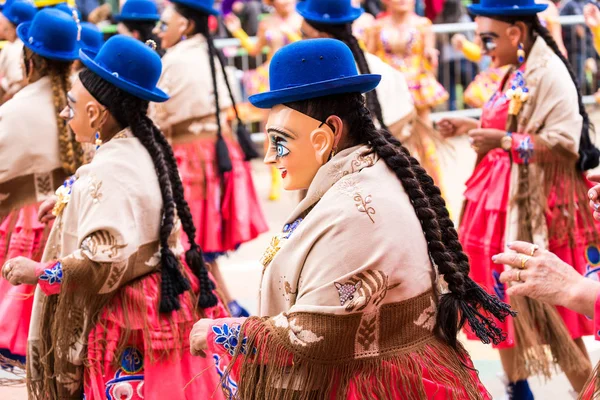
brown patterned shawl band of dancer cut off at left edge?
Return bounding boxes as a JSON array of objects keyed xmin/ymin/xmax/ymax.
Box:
[{"xmin": 0, "ymin": 168, "xmax": 67, "ymax": 216}]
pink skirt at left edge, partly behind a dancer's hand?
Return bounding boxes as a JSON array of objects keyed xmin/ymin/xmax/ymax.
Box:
[{"xmin": 0, "ymin": 203, "xmax": 52, "ymax": 356}]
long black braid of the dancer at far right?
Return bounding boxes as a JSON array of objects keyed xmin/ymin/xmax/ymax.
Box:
[{"xmin": 489, "ymin": 15, "xmax": 600, "ymax": 171}]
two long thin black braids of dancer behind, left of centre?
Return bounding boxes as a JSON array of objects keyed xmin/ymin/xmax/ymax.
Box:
[{"xmin": 175, "ymin": 3, "xmax": 258, "ymax": 173}]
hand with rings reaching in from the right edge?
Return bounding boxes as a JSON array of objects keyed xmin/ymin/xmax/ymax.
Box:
[{"xmin": 492, "ymin": 242, "xmax": 600, "ymax": 316}]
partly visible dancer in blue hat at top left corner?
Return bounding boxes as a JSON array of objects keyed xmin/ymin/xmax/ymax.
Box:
[{"xmin": 0, "ymin": 0, "xmax": 37, "ymax": 103}]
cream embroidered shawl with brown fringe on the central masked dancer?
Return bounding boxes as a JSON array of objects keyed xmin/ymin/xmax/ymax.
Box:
[{"xmin": 219, "ymin": 146, "xmax": 486, "ymax": 400}]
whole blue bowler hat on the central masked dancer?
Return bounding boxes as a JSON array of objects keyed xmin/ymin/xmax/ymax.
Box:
[{"xmin": 249, "ymin": 39, "xmax": 381, "ymax": 108}]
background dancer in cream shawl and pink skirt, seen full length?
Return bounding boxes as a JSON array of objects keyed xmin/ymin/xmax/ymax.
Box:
[{"xmin": 152, "ymin": 0, "xmax": 267, "ymax": 315}]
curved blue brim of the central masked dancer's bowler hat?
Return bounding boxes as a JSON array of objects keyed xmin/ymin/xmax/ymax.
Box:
[{"xmin": 248, "ymin": 74, "xmax": 381, "ymax": 108}]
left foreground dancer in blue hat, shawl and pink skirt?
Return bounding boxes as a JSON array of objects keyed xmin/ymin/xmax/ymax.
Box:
[{"xmin": 2, "ymin": 33, "xmax": 226, "ymax": 400}]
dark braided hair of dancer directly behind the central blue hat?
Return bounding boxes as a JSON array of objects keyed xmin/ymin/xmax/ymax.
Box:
[{"xmin": 306, "ymin": 20, "xmax": 388, "ymax": 130}]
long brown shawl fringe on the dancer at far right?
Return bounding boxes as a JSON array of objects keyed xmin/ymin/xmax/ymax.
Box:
[{"xmin": 507, "ymin": 115, "xmax": 598, "ymax": 379}]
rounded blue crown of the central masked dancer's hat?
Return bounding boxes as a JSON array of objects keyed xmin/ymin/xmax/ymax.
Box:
[{"xmin": 269, "ymin": 39, "xmax": 358, "ymax": 90}]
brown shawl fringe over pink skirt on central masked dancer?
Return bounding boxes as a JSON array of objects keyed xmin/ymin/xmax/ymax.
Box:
[{"xmin": 222, "ymin": 317, "xmax": 488, "ymax": 400}]
